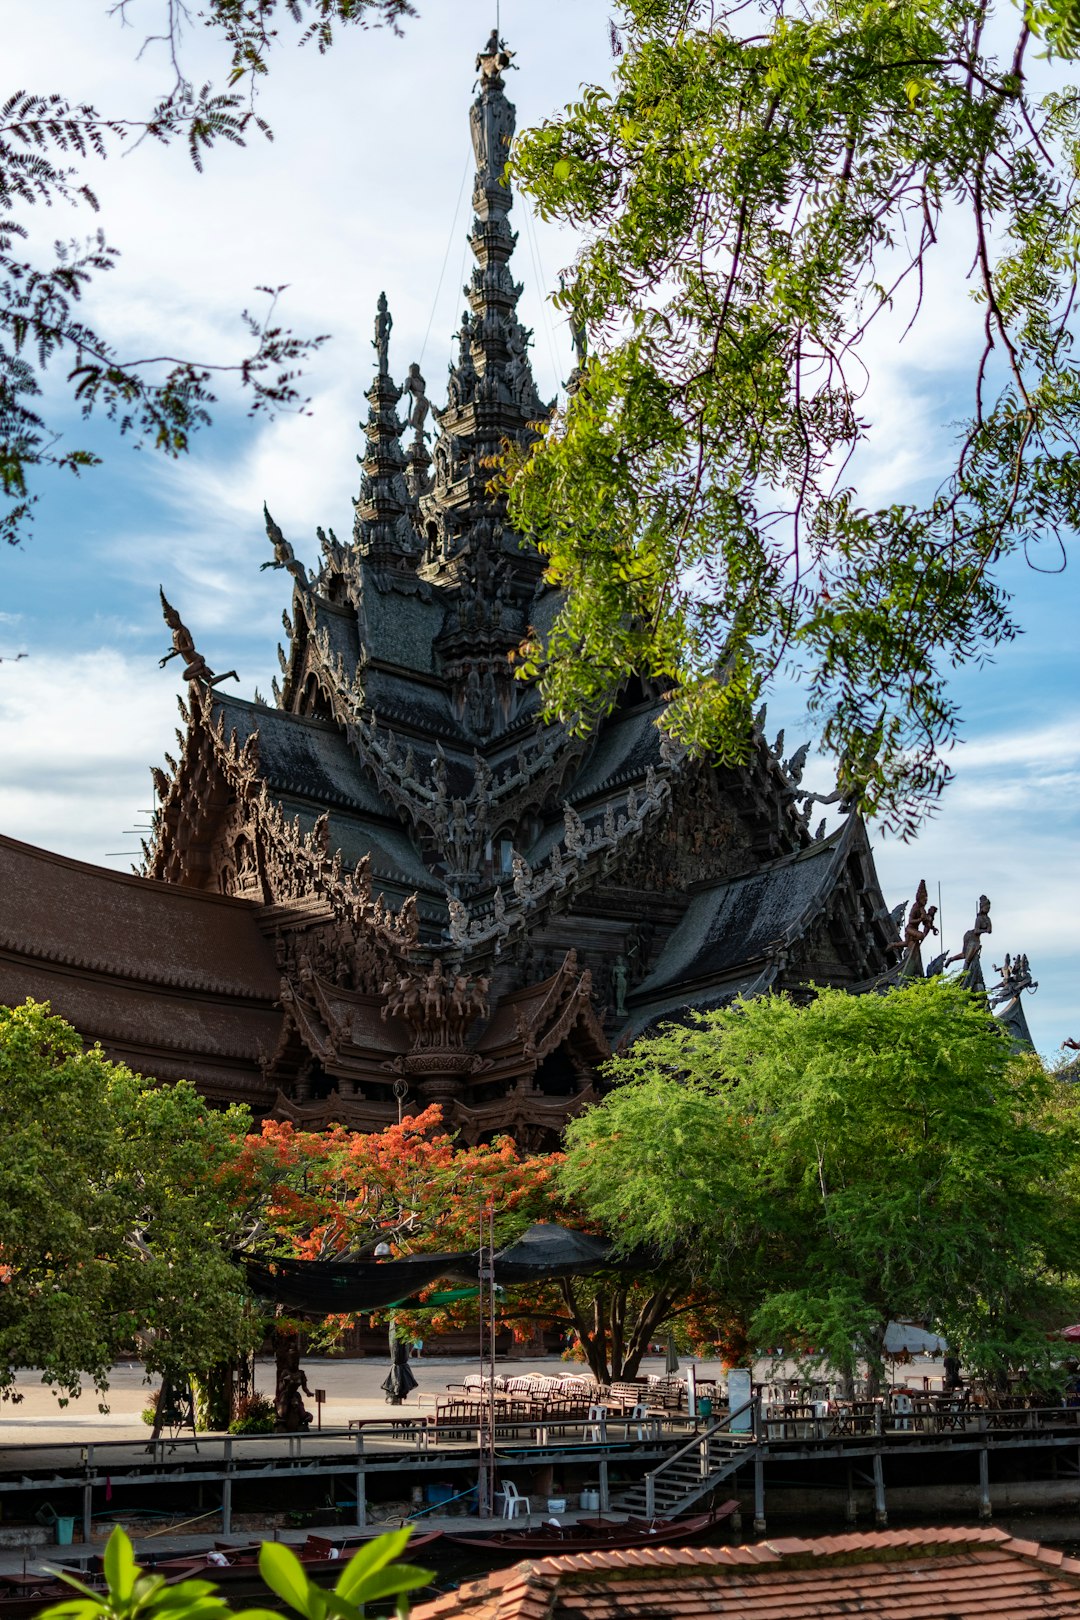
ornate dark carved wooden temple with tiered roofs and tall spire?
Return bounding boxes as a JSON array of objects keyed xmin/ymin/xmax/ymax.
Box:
[{"xmin": 0, "ymin": 37, "xmax": 904, "ymax": 1149}]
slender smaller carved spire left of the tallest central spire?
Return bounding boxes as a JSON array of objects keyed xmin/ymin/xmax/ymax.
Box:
[{"xmin": 353, "ymin": 293, "xmax": 419, "ymax": 575}]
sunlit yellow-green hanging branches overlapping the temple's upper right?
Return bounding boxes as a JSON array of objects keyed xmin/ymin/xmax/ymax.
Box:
[{"xmin": 512, "ymin": 0, "xmax": 1080, "ymax": 833}]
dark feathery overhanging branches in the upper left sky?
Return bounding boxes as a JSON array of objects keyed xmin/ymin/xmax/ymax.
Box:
[{"xmin": 0, "ymin": 0, "xmax": 415, "ymax": 544}]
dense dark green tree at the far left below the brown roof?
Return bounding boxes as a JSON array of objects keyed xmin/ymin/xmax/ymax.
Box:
[{"xmin": 0, "ymin": 1001, "xmax": 254, "ymax": 1398}]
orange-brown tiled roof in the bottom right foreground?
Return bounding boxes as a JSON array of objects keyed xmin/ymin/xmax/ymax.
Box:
[{"xmin": 413, "ymin": 1526, "xmax": 1080, "ymax": 1620}]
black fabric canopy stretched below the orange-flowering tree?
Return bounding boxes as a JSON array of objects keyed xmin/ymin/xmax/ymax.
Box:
[{"xmin": 244, "ymin": 1221, "xmax": 612, "ymax": 1315}]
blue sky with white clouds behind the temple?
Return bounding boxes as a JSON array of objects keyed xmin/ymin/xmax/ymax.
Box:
[{"xmin": 0, "ymin": 0, "xmax": 1080, "ymax": 1058}]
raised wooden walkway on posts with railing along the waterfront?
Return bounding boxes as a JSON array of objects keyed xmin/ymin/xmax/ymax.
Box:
[{"xmin": 0, "ymin": 1403, "xmax": 1080, "ymax": 1541}]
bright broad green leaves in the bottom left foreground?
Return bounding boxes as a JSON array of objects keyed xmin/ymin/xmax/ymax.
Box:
[{"xmin": 39, "ymin": 1524, "xmax": 431, "ymax": 1620}]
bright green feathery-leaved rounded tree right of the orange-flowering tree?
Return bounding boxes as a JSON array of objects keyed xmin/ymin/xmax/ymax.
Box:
[{"xmin": 562, "ymin": 980, "xmax": 1080, "ymax": 1375}]
